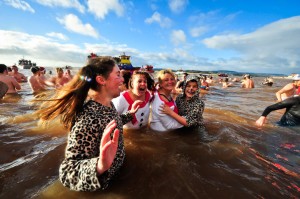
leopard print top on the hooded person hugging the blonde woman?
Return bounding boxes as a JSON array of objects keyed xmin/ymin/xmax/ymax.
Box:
[{"xmin": 175, "ymin": 94, "xmax": 205, "ymax": 127}]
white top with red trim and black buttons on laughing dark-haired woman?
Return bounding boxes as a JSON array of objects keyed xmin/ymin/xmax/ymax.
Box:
[{"xmin": 112, "ymin": 91, "xmax": 152, "ymax": 129}]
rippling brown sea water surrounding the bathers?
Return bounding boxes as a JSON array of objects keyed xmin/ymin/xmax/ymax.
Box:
[{"xmin": 0, "ymin": 69, "xmax": 300, "ymax": 199}]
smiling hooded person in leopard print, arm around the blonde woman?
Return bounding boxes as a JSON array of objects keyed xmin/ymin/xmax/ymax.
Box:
[{"xmin": 160, "ymin": 75, "xmax": 205, "ymax": 127}]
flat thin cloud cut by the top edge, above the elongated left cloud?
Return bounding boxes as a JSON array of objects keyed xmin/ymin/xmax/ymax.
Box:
[{"xmin": 36, "ymin": 0, "xmax": 85, "ymax": 13}]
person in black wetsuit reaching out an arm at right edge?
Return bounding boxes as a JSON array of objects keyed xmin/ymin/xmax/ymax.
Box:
[{"xmin": 255, "ymin": 96, "xmax": 300, "ymax": 126}]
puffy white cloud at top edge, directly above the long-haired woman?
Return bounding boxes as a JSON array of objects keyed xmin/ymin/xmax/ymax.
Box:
[{"xmin": 87, "ymin": 0, "xmax": 124, "ymax": 19}]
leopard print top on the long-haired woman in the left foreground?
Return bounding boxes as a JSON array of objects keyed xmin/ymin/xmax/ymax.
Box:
[{"xmin": 59, "ymin": 100, "xmax": 132, "ymax": 191}]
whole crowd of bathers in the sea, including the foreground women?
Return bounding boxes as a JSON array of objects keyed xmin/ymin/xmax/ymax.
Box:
[{"xmin": 0, "ymin": 56, "xmax": 300, "ymax": 191}]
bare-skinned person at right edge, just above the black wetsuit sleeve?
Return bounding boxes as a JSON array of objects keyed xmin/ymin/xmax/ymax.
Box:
[{"xmin": 276, "ymin": 74, "xmax": 300, "ymax": 102}]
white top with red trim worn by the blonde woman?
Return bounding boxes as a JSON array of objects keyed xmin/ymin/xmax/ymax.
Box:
[{"xmin": 150, "ymin": 92, "xmax": 183, "ymax": 131}]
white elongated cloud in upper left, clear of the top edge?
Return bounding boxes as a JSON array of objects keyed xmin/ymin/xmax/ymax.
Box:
[{"xmin": 56, "ymin": 14, "xmax": 99, "ymax": 38}]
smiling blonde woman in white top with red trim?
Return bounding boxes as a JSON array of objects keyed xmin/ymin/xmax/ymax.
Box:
[{"xmin": 150, "ymin": 69, "xmax": 183, "ymax": 131}]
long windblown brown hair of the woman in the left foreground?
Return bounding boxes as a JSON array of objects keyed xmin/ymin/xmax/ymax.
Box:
[{"xmin": 36, "ymin": 56, "xmax": 116, "ymax": 130}]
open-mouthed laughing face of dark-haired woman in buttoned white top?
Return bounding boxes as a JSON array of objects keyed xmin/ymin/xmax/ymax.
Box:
[{"xmin": 130, "ymin": 74, "xmax": 147, "ymax": 96}]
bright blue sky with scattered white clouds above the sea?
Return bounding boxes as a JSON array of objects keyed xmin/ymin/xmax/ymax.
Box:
[{"xmin": 0, "ymin": 0, "xmax": 300, "ymax": 75}]
